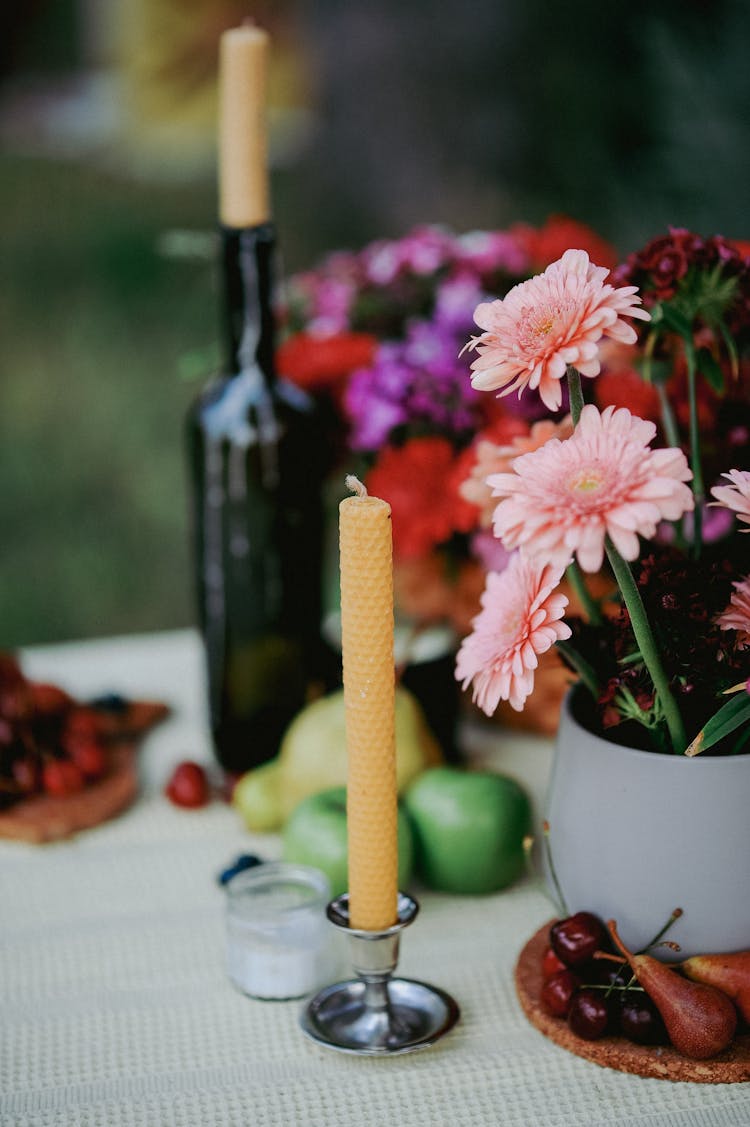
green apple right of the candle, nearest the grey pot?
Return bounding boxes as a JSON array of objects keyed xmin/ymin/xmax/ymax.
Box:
[{"xmin": 403, "ymin": 766, "xmax": 531, "ymax": 894}]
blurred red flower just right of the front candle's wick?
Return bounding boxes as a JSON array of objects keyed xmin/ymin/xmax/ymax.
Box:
[{"xmin": 365, "ymin": 436, "xmax": 476, "ymax": 560}]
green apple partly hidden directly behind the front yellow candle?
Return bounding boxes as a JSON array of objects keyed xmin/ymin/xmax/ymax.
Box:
[{"xmin": 281, "ymin": 787, "xmax": 414, "ymax": 896}]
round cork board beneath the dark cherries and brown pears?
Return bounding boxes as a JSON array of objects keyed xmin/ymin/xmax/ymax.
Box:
[{"xmin": 515, "ymin": 923, "xmax": 750, "ymax": 1084}]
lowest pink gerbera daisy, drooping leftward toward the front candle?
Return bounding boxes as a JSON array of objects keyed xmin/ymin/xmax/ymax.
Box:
[{"xmin": 456, "ymin": 552, "xmax": 571, "ymax": 716}]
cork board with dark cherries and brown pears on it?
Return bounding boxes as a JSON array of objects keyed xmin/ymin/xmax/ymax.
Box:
[{"xmin": 515, "ymin": 908, "xmax": 750, "ymax": 1084}]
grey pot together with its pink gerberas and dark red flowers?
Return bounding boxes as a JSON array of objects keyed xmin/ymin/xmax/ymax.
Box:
[{"xmin": 457, "ymin": 230, "xmax": 750, "ymax": 978}]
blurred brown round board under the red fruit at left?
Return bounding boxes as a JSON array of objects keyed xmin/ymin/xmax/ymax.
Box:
[{"xmin": 0, "ymin": 743, "xmax": 138, "ymax": 845}]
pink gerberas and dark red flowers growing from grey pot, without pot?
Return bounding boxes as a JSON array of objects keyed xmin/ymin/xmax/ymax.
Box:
[{"xmin": 457, "ymin": 231, "xmax": 750, "ymax": 755}]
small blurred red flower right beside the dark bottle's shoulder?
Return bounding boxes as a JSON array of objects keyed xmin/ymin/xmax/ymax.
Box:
[{"xmin": 276, "ymin": 332, "xmax": 378, "ymax": 391}]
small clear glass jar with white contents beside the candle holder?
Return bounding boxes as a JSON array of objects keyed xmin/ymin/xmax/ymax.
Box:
[{"xmin": 227, "ymin": 861, "xmax": 341, "ymax": 1001}]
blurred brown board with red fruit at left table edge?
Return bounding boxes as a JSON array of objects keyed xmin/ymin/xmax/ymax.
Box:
[{"xmin": 0, "ymin": 654, "xmax": 169, "ymax": 844}]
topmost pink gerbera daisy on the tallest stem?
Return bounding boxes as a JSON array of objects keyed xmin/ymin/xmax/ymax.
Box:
[{"xmin": 467, "ymin": 250, "xmax": 651, "ymax": 411}]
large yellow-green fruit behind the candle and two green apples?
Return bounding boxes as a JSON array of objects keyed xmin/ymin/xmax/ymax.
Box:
[{"xmin": 279, "ymin": 685, "xmax": 442, "ymax": 822}]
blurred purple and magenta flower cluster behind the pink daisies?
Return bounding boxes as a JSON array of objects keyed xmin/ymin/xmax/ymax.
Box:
[{"xmin": 280, "ymin": 225, "xmax": 572, "ymax": 453}]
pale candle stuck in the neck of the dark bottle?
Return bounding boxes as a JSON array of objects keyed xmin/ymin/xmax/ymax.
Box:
[{"xmin": 219, "ymin": 21, "xmax": 271, "ymax": 228}]
